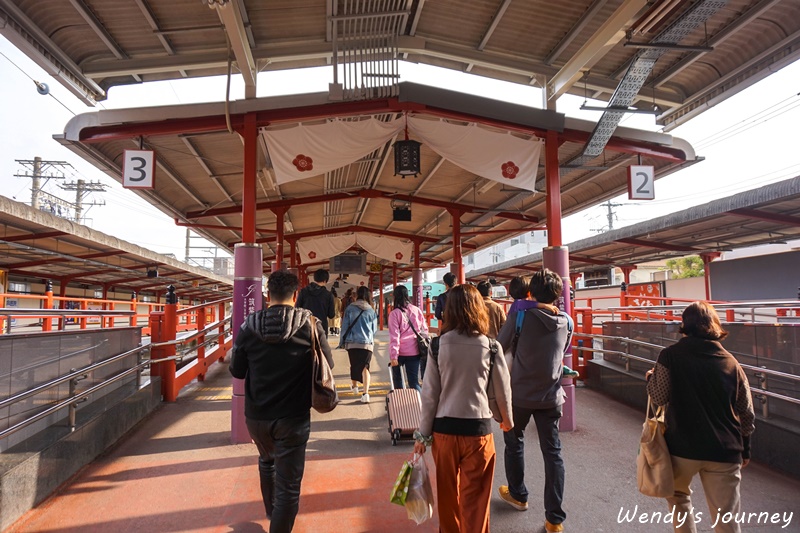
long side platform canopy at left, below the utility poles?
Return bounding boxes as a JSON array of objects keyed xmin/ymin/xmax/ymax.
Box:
[{"xmin": 0, "ymin": 196, "xmax": 233, "ymax": 301}]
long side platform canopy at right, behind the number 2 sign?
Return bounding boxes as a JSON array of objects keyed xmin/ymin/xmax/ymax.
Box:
[{"xmin": 466, "ymin": 177, "xmax": 800, "ymax": 281}]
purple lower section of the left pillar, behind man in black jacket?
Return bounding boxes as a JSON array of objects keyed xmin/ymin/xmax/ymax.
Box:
[{"xmin": 231, "ymin": 243, "xmax": 263, "ymax": 444}]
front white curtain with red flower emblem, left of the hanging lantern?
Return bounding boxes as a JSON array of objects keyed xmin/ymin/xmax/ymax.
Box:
[{"xmin": 263, "ymin": 118, "xmax": 405, "ymax": 184}]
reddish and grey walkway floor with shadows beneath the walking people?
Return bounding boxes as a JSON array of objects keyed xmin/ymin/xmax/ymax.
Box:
[{"xmin": 7, "ymin": 333, "xmax": 800, "ymax": 533}]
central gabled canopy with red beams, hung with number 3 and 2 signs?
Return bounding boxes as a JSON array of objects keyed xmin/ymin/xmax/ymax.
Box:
[{"xmin": 55, "ymin": 83, "xmax": 701, "ymax": 274}]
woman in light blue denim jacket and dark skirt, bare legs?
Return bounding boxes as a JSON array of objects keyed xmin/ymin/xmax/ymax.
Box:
[{"xmin": 339, "ymin": 287, "xmax": 378, "ymax": 403}]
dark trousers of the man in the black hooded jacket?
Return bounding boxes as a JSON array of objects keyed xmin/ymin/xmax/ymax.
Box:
[{"xmin": 246, "ymin": 412, "xmax": 311, "ymax": 533}]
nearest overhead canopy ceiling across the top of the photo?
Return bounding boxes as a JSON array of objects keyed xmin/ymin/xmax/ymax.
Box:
[{"xmin": 0, "ymin": 0, "xmax": 800, "ymax": 130}]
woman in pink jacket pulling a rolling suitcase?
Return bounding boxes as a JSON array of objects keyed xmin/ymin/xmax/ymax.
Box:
[{"xmin": 389, "ymin": 285, "xmax": 428, "ymax": 391}]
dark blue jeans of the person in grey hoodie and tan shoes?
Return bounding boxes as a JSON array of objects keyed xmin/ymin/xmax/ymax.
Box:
[{"xmin": 503, "ymin": 405, "xmax": 567, "ymax": 524}]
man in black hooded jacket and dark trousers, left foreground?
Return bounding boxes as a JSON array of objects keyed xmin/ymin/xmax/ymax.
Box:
[{"xmin": 230, "ymin": 270, "xmax": 333, "ymax": 533}]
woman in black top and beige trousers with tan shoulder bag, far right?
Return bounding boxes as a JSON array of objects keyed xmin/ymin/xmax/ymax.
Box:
[{"xmin": 647, "ymin": 302, "xmax": 755, "ymax": 533}]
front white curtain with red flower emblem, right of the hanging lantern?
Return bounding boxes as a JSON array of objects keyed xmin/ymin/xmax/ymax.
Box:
[{"xmin": 408, "ymin": 117, "xmax": 542, "ymax": 191}]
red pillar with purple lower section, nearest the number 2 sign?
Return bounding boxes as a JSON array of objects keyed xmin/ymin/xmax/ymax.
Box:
[{"xmin": 542, "ymin": 130, "xmax": 575, "ymax": 431}]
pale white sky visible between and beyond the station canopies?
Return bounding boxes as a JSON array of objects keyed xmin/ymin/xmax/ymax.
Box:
[{"xmin": 0, "ymin": 36, "xmax": 800, "ymax": 259}]
